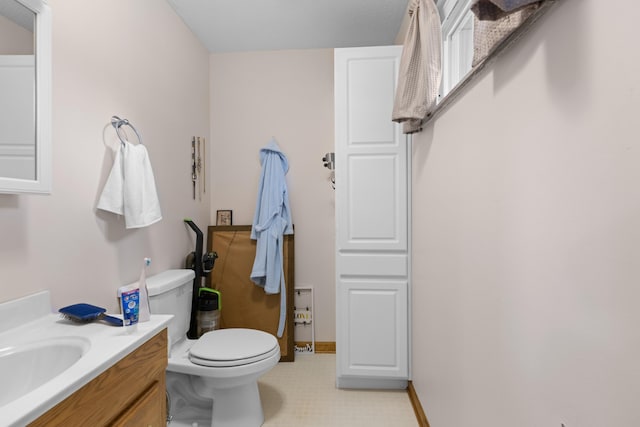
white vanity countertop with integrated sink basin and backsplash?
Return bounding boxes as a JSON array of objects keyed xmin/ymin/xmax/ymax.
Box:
[{"xmin": 0, "ymin": 290, "xmax": 172, "ymax": 427}]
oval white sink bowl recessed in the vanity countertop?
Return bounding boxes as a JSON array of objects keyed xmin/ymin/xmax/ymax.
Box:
[{"xmin": 0, "ymin": 336, "xmax": 91, "ymax": 407}]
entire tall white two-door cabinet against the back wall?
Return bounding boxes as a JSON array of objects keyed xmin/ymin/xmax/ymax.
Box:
[{"xmin": 334, "ymin": 46, "xmax": 411, "ymax": 388}]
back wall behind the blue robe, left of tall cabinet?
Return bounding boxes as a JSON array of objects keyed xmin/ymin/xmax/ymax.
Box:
[{"xmin": 210, "ymin": 49, "xmax": 335, "ymax": 341}]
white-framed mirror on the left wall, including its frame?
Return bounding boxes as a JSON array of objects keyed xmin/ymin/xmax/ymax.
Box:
[{"xmin": 0, "ymin": 0, "xmax": 51, "ymax": 194}]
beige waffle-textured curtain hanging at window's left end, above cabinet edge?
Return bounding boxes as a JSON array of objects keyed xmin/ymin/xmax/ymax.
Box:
[{"xmin": 391, "ymin": 0, "xmax": 442, "ymax": 133}]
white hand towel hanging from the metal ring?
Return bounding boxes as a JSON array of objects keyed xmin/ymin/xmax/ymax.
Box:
[{"xmin": 98, "ymin": 141, "xmax": 162, "ymax": 228}]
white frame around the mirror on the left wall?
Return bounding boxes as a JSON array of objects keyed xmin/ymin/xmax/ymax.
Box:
[{"xmin": 0, "ymin": 0, "xmax": 52, "ymax": 194}]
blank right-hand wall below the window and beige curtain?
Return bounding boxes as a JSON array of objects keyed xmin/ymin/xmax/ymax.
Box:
[{"xmin": 413, "ymin": 0, "xmax": 640, "ymax": 427}]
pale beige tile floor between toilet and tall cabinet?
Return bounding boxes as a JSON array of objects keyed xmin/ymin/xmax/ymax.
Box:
[{"xmin": 258, "ymin": 354, "xmax": 418, "ymax": 427}]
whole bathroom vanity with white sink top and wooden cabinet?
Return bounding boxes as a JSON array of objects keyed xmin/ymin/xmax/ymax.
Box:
[{"xmin": 0, "ymin": 291, "xmax": 172, "ymax": 427}]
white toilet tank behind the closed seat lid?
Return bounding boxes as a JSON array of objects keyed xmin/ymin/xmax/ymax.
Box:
[{"xmin": 147, "ymin": 269, "xmax": 195, "ymax": 348}]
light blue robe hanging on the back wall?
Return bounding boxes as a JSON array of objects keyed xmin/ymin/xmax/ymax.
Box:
[{"xmin": 250, "ymin": 139, "xmax": 293, "ymax": 337}]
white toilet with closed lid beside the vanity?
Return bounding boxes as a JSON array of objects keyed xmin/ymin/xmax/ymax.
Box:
[{"xmin": 147, "ymin": 269, "xmax": 280, "ymax": 427}]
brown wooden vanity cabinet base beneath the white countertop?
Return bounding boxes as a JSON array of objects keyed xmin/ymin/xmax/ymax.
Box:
[{"xmin": 30, "ymin": 329, "xmax": 167, "ymax": 427}]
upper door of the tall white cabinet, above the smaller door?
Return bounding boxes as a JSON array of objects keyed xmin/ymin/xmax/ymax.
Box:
[{"xmin": 335, "ymin": 46, "xmax": 407, "ymax": 251}]
